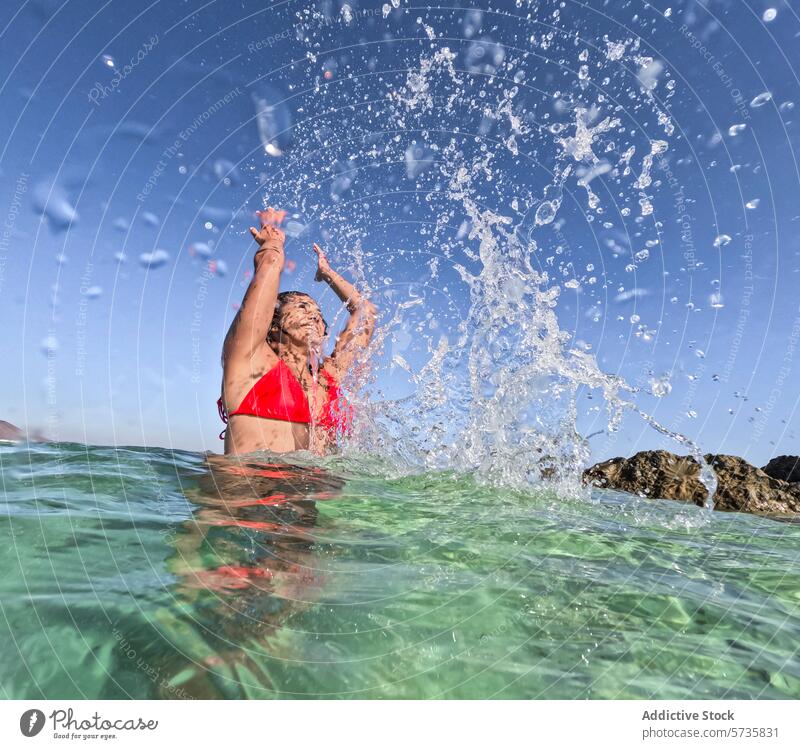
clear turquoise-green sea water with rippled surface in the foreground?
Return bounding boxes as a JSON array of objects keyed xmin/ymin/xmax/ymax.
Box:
[{"xmin": 0, "ymin": 444, "xmax": 800, "ymax": 699}]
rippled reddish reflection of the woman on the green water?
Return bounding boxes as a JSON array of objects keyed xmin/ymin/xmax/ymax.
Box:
[{"xmin": 160, "ymin": 455, "xmax": 344, "ymax": 699}]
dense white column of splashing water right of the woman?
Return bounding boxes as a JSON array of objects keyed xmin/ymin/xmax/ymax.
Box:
[{"xmin": 360, "ymin": 48, "xmax": 713, "ymax": 496}]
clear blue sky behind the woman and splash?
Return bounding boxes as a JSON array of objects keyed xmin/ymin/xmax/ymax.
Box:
[{"xmin": 0, "ymin": 0, "xmax": 800, "ymax": 464}]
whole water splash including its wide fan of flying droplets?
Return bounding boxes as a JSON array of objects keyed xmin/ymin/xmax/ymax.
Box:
[{"xmin": 260, "ymin": 29, "xmax": 713, "ymax": 506}]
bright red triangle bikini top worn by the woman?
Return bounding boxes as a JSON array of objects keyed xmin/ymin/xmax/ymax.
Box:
[{"xmin": 217, "ymin": 359, "xmax": 352, "ymax": 439}]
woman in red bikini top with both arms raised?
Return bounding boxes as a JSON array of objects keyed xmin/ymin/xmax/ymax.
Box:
[{"xmin": 217, "ymin": 211, "xmax": 376, "ymax": 455}]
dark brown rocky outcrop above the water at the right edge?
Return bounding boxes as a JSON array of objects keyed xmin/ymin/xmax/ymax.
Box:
[{"xmin": 583, "ymin": 450, "xmax": 800, "ymax": 515}]
